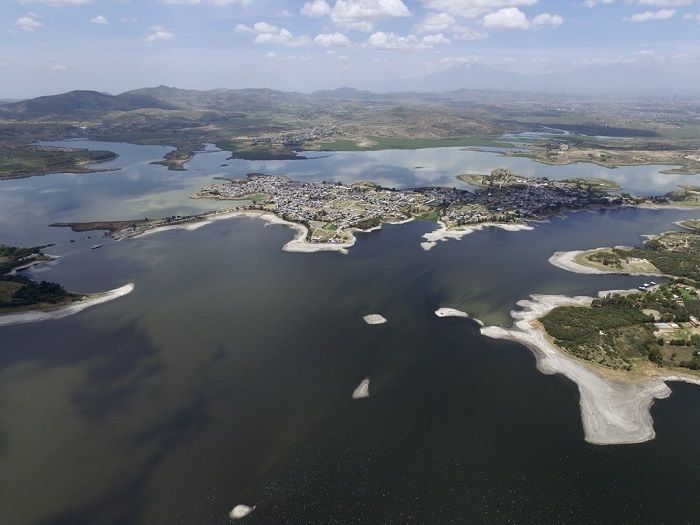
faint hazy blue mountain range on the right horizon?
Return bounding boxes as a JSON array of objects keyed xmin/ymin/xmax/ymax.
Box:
[{"xmin": 401, "ymin": 64, "xmax": 700, "ymax": 96}]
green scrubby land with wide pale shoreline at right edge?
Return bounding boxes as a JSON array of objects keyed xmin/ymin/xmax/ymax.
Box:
[{"xmin": 482, "ymin": 231, "xmax": 700, "ymax": 444}]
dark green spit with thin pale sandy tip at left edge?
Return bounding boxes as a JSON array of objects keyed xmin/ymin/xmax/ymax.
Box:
[{"xmin": 0, "ymin": 245, "xmax": 134, "ymax": 327}]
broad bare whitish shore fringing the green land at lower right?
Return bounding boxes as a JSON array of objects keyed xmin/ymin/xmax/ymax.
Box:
[{"xmin": 481, "ymin": 291, "xmax": 700, "ymax": 445}]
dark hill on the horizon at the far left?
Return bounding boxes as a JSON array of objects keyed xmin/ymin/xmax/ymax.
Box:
[{"xmin": 0, "ymin": 91, "xmax": 174, "ymax": 119}]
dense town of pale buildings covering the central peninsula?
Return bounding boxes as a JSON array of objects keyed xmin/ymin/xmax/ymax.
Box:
[{"xmin": 197, "ymin": 175, "xmax": 636, "ymax": 242}]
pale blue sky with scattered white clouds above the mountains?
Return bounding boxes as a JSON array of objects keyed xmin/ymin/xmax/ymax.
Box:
[{"xmin": 0, "ymin": 0, "xmax": 700, "ymax": 99}]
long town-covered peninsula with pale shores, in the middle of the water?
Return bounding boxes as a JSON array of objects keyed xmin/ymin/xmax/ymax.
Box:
[{"xmin": 64, "ymin": 170, "xmax": 639, "ymax": 251}]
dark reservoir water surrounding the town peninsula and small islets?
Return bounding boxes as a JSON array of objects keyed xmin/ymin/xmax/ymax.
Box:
[{"xmin": 0, "ymin": 143, "xmax": 700, "ymax": 525}]
